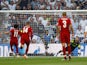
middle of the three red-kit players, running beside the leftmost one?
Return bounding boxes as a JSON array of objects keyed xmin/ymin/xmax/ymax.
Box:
[{"xmin": 21, "ymin": 22, "xmax": 33, "ymax": 58}]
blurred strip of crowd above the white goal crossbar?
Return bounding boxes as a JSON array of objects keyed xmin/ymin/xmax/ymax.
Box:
[{"xmin": 0, "ymin": 0, "xmax": 87, "ymax": 10}]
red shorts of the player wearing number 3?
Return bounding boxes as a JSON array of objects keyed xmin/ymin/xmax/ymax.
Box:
[{"xmin": 60, "ymin": 32, "xmax": 70, "ymax": 43}]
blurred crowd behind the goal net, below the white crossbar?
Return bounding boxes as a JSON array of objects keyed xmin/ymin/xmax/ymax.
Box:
[{"xmin": 0, "ymin": 13, "xmax": 87, "ymax": 44}]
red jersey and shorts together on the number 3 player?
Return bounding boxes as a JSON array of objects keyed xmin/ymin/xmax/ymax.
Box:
[{"xmin": 58, "ymin": 17, "xmax": 71, "ymax": 43}]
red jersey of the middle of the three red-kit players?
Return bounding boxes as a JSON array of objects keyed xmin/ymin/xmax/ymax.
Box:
[{"xmin": 22, "ymin": 26, "xmax": 33, "ymax": 38}]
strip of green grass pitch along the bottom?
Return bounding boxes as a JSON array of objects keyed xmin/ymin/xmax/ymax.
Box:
[{"xmin": 0, "ymin": 57, "xmax": 87, "ymax": 65}]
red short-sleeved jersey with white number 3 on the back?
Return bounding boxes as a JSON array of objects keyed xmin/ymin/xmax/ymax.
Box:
[{"xmin": 58, "ymin": 17, "xmax": 71, "ymax": 33}]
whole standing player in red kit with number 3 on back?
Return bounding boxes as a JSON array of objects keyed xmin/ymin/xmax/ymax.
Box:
[{"xmin": 58, "ymin": 12, "xmax": 74, "ymax": 60}]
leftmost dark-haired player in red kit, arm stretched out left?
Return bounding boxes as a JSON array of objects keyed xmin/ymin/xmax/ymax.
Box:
[{"xmin": 5, "ymin": 24, "xmax": 21, "ymax": 57}]
